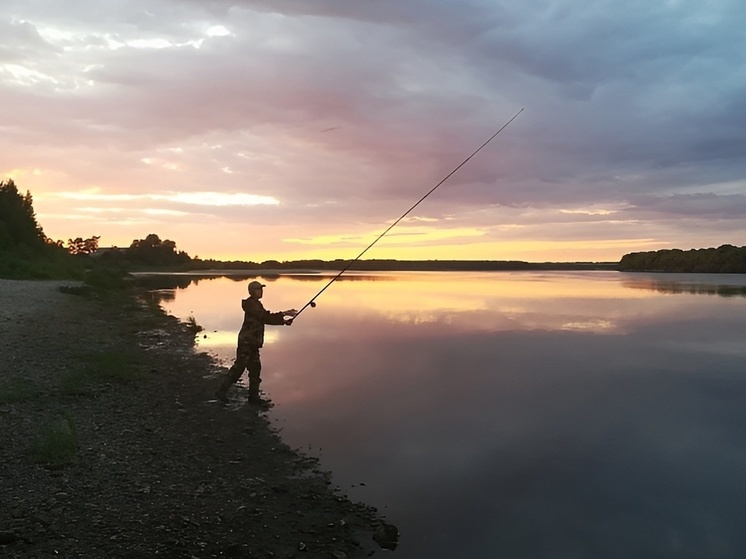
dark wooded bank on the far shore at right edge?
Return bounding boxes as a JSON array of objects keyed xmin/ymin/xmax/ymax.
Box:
[{"xmin": 618, "ymin": 245, "xmax": 746, "ymax": 274}]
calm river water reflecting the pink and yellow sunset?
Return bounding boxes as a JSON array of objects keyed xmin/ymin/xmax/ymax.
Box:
[{"xmin": 150, "ymin": 272, "xmax": 746, "ymax": 559}]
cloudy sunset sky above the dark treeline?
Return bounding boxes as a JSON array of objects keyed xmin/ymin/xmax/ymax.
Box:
[{"xmin": 0, "ymin": 0, "xmax": 746, "ymax": 262}]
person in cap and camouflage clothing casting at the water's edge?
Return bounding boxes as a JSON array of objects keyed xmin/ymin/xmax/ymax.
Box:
[{"xmin": 215, "ymin": 281, "xmax": 298, "ymax": 404}]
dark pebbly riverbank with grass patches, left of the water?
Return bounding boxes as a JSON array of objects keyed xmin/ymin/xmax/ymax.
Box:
[{"xmin": 0, "ymin": 280, "xmax": 391, "ymax": 559}]
